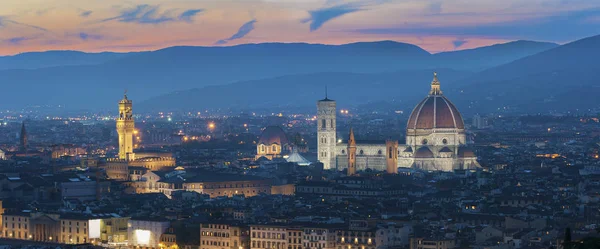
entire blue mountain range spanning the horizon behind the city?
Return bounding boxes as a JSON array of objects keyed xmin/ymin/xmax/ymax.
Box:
[{"xmin": 0, "ymin": 37, "xmax": 600, "ymax": 112}]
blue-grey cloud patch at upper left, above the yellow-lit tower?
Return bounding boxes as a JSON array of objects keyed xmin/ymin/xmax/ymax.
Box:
[{"xmin": 100, "ymin": 4, "xmax": 203, "ymax": 24}]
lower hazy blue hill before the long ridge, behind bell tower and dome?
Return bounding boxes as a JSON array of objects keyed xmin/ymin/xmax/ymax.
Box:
[{"xmin": 136, "ymin": 69, "xmax": 471, "ymax": 111}]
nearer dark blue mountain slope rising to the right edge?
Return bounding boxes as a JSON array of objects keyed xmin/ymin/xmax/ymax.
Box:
[{"xmin": 451, "ymin": 36, "xmax": 600, "ymax": 112}]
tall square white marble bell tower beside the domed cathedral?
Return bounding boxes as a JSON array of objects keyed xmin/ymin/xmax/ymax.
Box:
[{"xmin": 317, "ymin": 90, "xmax": 337, "ymax": 169}]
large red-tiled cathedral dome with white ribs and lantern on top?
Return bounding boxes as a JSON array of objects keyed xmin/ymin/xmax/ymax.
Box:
[{"xmin": 406, "ymin": 73, "xmax": 465, "ymax": 129}]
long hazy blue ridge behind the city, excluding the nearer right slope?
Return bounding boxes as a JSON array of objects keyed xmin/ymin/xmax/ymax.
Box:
[{"xmin": 0, "ymin": 38, "xmax": 555, "ymax": 109}]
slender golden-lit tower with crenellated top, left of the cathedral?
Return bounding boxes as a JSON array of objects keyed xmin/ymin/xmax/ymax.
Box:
[{"xmin": 117, "ymin": 91, "xmax": 135, "ymax": 161}]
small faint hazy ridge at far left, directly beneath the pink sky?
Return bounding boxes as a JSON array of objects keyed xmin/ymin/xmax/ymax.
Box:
[{"xmin": 0, "ymin": 51, "xmax": 134, "ymax": 70}]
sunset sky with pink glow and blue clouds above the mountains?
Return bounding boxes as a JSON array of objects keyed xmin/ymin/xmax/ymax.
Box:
[{"xmin": 0, "ymin": 0, "xmax": 600, "ymax": 55}]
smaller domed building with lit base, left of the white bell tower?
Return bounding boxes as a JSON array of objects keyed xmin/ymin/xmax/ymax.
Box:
[{"xmin": 255, "ymin": 126, "xmax": 291, "ymax": 160}]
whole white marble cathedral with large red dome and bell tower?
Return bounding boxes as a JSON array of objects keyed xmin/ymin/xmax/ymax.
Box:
[{"xmin": 317, "ymin": 73, "xmax": 480, "ymax": 175}]
